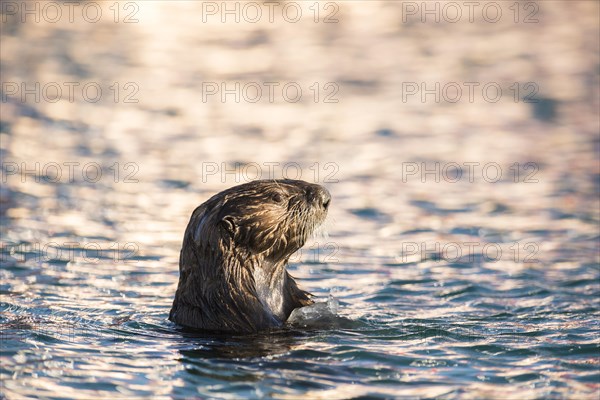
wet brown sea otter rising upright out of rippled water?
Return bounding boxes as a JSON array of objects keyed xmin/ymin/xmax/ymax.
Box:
[{"xmin": 169, "ymin": 179, "xmax": 331, "ymax": 333}]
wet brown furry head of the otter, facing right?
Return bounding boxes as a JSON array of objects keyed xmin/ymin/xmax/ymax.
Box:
[{"xmin": 216, "ymin": 180, "xmax": 331, "ymax": 262}]
